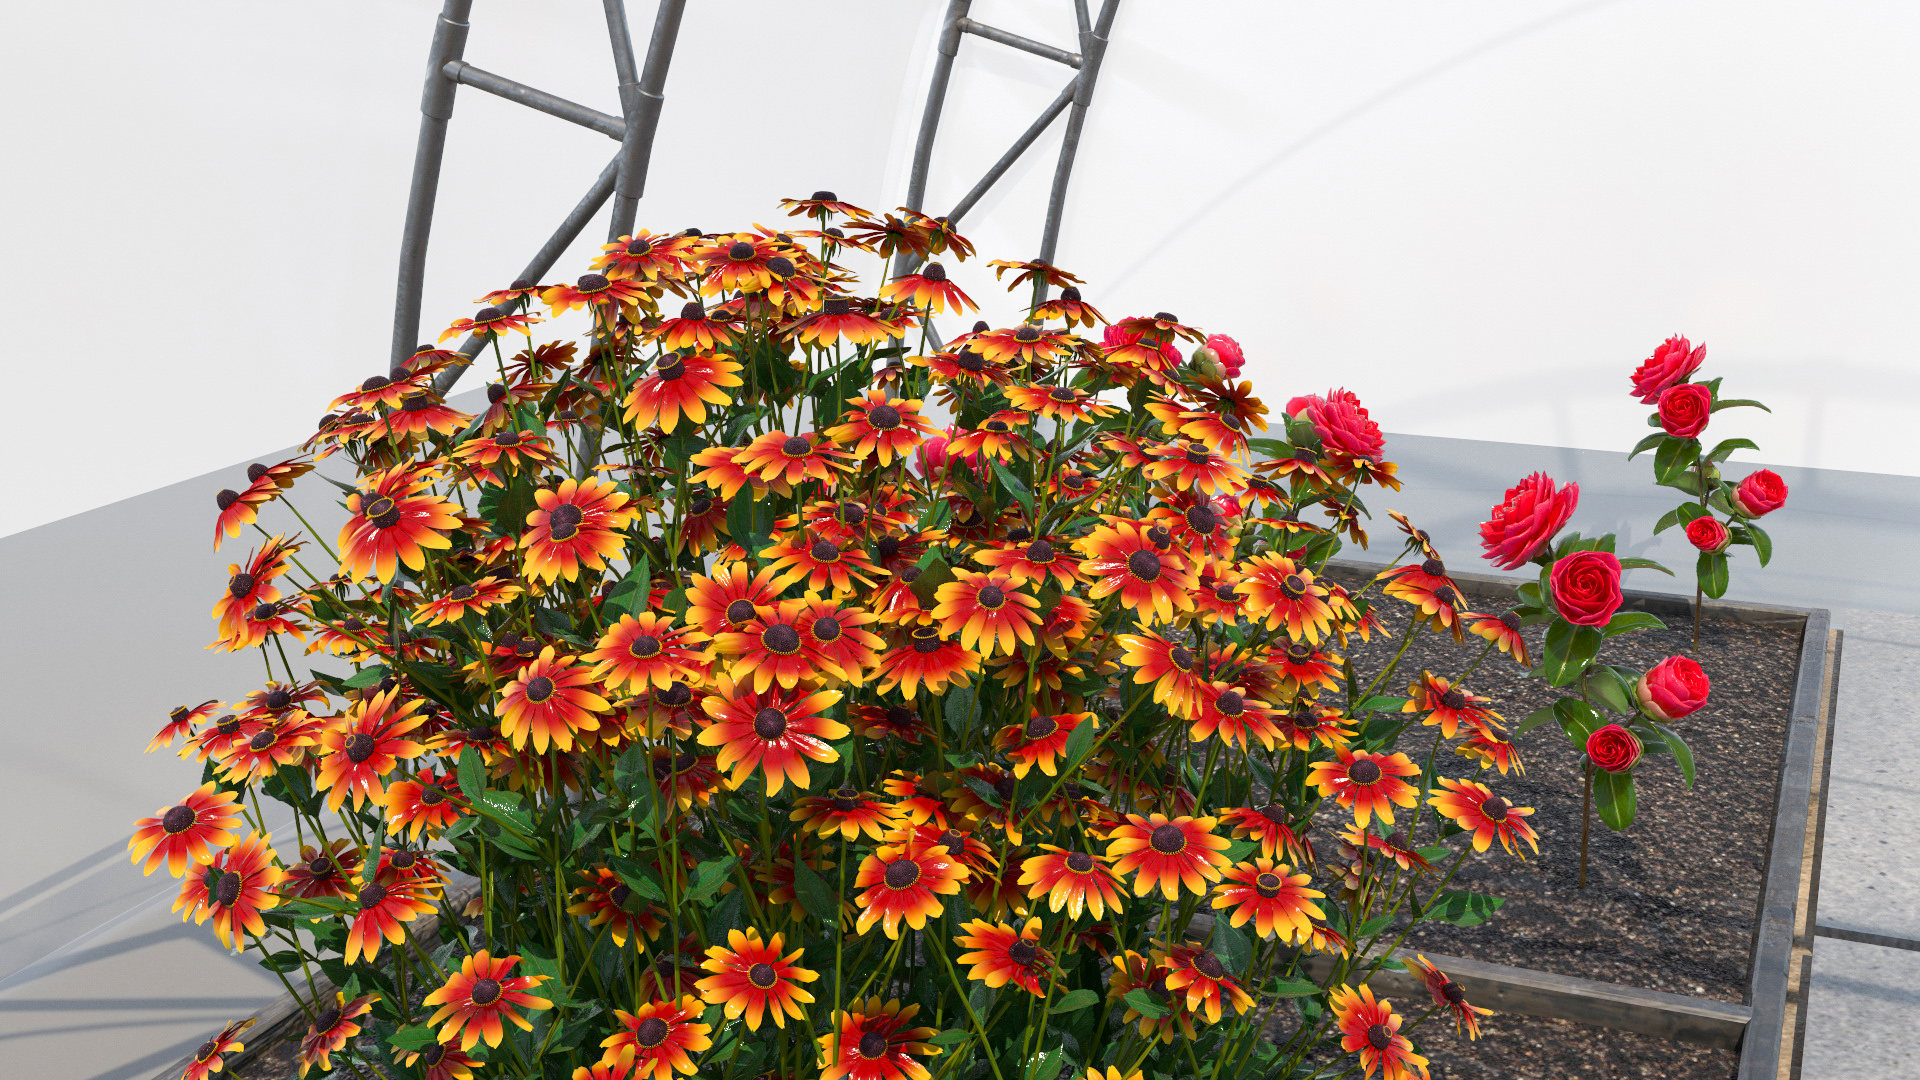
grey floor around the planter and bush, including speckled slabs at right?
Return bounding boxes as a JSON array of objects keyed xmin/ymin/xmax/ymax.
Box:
[{"xmin": 0, "ymin": 424, "xmax": 1920, "ymax": 1080}]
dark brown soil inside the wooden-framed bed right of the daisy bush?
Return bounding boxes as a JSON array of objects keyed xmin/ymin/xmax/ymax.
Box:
[{"xmin": 1328, "ymin": 557, "xmax": 1799, "ymax": 1080}]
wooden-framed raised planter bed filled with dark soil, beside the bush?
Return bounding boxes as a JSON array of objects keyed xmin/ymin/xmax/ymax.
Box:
[{"xmin": 1332, "ymin": 563, "xmax": 1839, "ymax": 1080}]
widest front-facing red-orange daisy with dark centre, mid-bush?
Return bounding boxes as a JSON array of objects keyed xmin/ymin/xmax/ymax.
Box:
[{"xmin": 701, "ymin": 675, "xmax": 849, "ymax": 796}]
